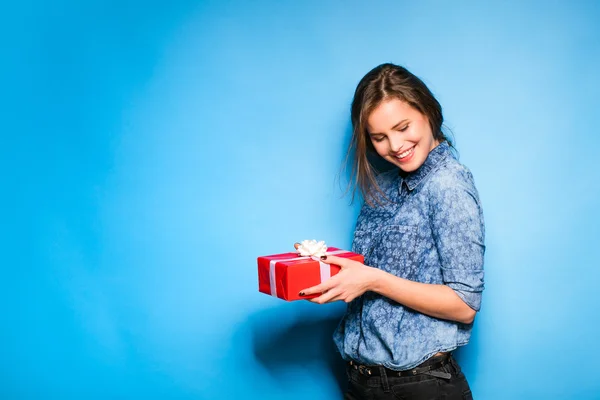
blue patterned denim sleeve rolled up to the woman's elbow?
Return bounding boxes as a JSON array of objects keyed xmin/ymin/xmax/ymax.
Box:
[{"xmin": 430, "ymin": 173, "xmax": 485, "ymax": 311}]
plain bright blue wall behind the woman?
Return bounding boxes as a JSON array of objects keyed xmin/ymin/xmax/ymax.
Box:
[{"xmin": 0, "ymin": 0, "xmax": 600, "ymax": 399}]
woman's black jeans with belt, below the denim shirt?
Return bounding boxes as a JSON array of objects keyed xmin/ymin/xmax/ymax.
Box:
[{"xmin": 344, "ymin": 355, "xmax": 473, "ymax": 400}]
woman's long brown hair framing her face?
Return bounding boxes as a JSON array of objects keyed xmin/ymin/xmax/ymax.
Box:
[{"xmin": 345, "ymin": 63, "xmax": 452, "ymax": 206}]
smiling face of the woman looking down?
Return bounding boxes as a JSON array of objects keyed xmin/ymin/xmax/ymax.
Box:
[{"xmin": 367, "ymin": 99, "xmax": 439, "ymax": 172}]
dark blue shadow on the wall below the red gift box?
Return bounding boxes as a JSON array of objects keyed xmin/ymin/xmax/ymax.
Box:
[{"xmin": 249, "ymin": 303, "xmax": 346, "ymax": 392}]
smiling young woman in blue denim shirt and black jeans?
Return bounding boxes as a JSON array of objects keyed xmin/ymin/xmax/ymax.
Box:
[{"xmin": 300, "ymin": 64, "xmax": 485, "ymax": 399}]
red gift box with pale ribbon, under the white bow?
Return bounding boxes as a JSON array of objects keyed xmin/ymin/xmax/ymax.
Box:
[{"xmin": 258, "ymin": 247, "xmax": 364, "ymax": 301}]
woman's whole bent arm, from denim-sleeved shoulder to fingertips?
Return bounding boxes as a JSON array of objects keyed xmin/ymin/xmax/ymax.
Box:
[{"xmin": 303, "ymin": 170, "xmax": 485, "ymax": 324}]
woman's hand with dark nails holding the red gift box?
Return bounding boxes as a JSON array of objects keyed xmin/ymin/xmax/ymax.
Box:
[{"xmin": 300, "ymin": 256, "xmax": 380, "ymax": 304}]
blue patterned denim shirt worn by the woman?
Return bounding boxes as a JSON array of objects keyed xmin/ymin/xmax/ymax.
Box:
[{"xmin": 334, "ymin": 142, "xmax": 485, "ymax": 370}]
